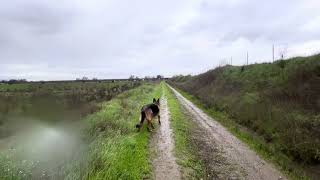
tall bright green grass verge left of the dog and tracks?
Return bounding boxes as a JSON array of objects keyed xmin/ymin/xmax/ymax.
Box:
[{"xmin": 86, "ymin": 82, "xmax": 161, "ymax": 179}]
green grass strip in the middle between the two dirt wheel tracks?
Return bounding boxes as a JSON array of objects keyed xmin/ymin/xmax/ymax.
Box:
[{"xmin": 161, "ymin": 83, "xmax": 204, "ymax": 179}]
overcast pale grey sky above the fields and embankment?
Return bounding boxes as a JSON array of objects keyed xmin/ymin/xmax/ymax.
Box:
[{"xmin": 0, "ymin": 0, "xmax": 320, "ymax": 80}]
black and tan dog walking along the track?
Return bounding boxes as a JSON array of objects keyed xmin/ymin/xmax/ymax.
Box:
[{"xmin": 136, "ymin": 98, "xmax": 161, "ymax": 131}]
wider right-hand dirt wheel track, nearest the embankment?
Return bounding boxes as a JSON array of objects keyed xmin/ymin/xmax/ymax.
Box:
[{"xmin": 169, "ymin": 86, "xmax": 285, "ymax": 180}]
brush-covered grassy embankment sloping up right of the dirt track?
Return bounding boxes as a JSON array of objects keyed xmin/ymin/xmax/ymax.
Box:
[{"xmin": 170, "ymin": 55, "xmax": 320, "ymax": 178}]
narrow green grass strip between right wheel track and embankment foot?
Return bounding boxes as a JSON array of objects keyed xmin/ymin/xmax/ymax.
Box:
[{"xmin": 172, "ymin": 88, "xmax": 308, "ymax": 179}]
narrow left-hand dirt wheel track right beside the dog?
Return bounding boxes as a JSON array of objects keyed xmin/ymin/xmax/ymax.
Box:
[{"xmin": 151, "ymin": 97, "xmax": 181, "ymax": 180}]
